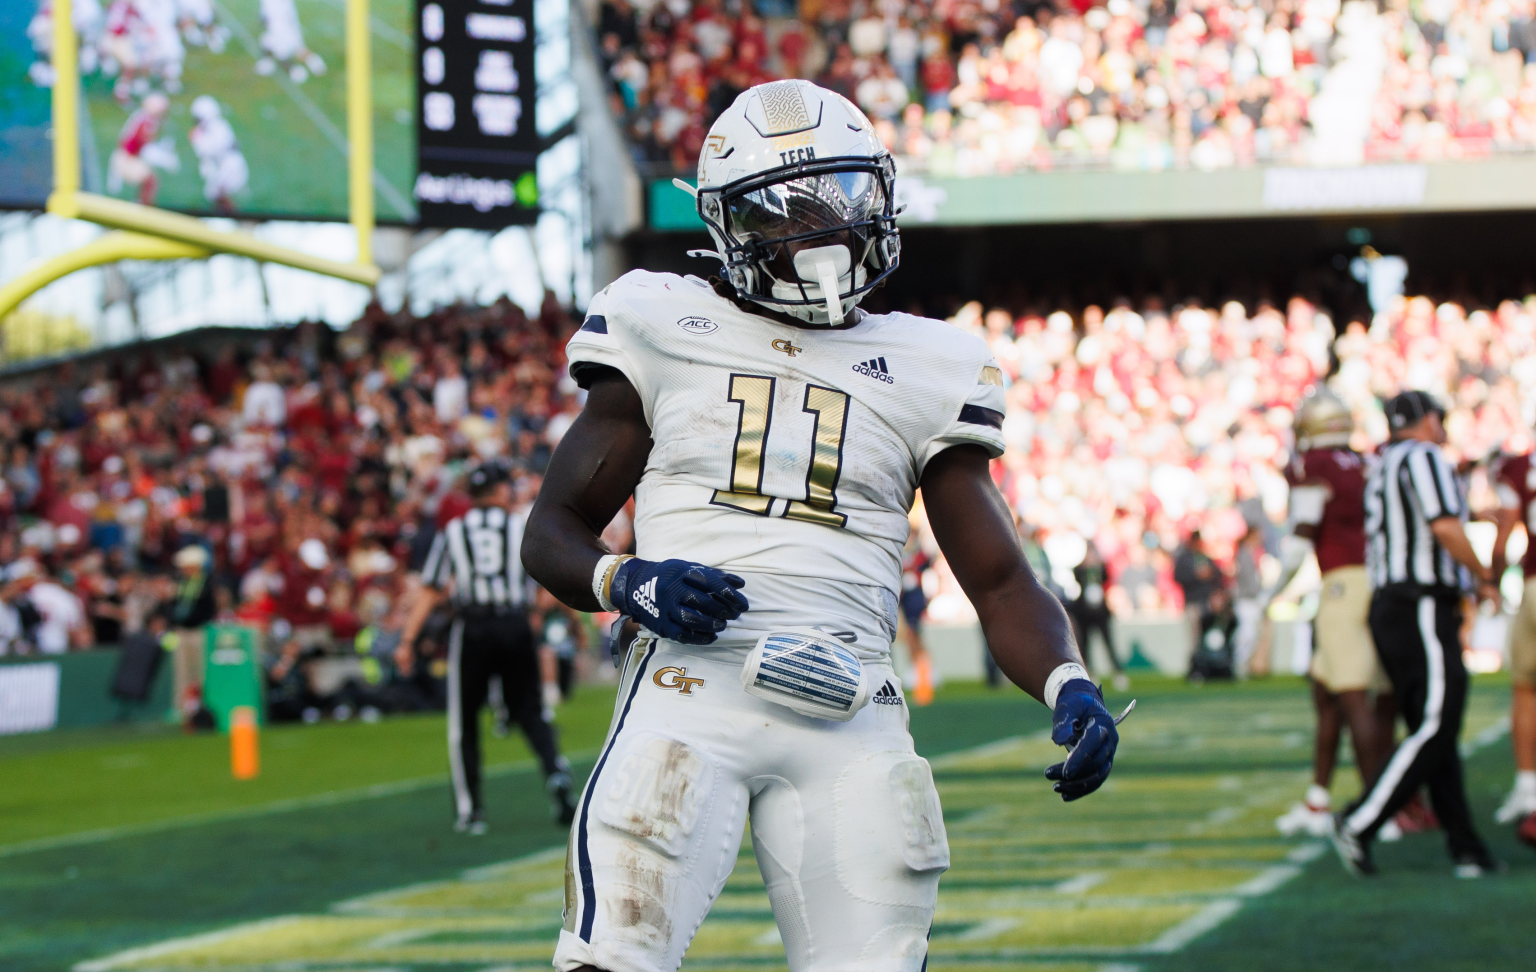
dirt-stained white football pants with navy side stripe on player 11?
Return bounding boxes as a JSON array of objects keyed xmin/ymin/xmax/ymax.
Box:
[{"xmin": 554, "ymin": 639, "xmax": 949, "ymax": 972}]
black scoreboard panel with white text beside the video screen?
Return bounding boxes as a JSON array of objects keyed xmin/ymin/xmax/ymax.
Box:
[{"xmin": 413, "ymin": 0, "xmax": 539, "ymax": 229}]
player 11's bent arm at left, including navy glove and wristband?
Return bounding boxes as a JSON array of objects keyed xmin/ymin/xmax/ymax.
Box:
[{"xmin": 522, "ymin": 369, "xmax": 746, "ymax": 645}]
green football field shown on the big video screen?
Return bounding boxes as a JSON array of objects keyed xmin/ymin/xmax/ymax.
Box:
[{"xmin": 81, "ymin": 0, "xmax": 416, "ymax": 223}]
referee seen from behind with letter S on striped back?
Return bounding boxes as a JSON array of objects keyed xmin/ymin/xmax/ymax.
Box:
[{"xmin": 401, "ymin": 465, "xmax": 574, "ymax": 834}]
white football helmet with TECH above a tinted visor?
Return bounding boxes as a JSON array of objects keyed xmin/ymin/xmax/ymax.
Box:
[{"xmin": 679, "ymin": 80, "xmax": 902, "ymax": 327}]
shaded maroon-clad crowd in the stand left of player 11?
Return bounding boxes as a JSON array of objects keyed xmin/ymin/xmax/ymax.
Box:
[{"xmin": 0, "ymin": 296, "xmax": 602, "ymax": 715}]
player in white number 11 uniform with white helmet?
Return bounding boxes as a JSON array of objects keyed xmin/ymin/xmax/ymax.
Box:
[{"xmin": 522, "ymin": 81, "xmax": 1118, "ymax": 972}]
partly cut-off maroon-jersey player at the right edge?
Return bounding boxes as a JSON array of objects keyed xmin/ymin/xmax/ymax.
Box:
[{"xmin": 1493, "ymin": 453, "xmax": 1536, "ymax": 843}]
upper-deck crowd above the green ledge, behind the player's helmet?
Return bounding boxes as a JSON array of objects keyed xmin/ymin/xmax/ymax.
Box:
[{"xmin": 596, "ymin": 0, "xmax": 1536, "ymax": 175}]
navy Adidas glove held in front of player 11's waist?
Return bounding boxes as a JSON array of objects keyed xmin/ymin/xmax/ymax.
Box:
[{"xmin": 608, "ymin": 557, "xmax": 746, "ymax": 645}]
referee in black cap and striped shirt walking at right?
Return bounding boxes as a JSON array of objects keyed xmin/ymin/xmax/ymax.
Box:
[{"xmin": 1333, "ymin": 392, "xmax": 1498, "ymax": 877}]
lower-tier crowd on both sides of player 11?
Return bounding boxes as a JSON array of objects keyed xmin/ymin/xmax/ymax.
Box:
[{"xmin": 0, "ymin": 277, "xmax": 1536, "ymax": 697}]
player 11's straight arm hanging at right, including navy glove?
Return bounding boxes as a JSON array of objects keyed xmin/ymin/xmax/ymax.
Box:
[{"xmin": 919, "ymin": 445, "xmax": 1120, "ymax": 800}]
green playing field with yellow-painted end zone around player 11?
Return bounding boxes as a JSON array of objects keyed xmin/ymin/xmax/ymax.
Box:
[{"xmin": 0, "ymin": 677, "xmax": 1536, "ymax": 972}]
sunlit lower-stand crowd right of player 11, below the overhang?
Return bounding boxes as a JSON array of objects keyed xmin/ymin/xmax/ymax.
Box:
[{"xmin": 931, "ymin": 296, "xmax": 1536, "ymax": 616}]
